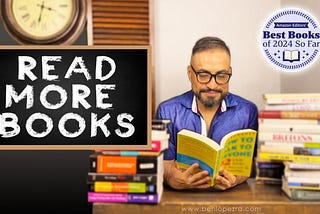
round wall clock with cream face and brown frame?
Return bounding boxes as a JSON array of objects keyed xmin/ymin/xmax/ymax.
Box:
[{"xmin": 1, "ymin": 0, "xmax": 86, "ymax": 45}]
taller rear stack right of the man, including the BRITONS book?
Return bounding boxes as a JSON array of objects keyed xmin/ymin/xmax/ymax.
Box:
[{"xmin": 256, "ymin": 93, "xmax": 320, "ymax": 184}]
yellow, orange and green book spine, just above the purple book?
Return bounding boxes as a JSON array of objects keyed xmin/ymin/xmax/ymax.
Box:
[{"xmin": 88, "ymin": 181, "xmax": 157, "ymax": 193}]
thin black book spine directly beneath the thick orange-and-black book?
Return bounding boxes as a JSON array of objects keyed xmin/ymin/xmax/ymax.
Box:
[{"xmin": 87, "ymin": 172, "xmax": 158, "ymax": 184}]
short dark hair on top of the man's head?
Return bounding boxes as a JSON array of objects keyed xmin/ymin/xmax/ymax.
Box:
[{"xmin": 192, "ymin": 36, "xmax": 231, "ymax": 56}]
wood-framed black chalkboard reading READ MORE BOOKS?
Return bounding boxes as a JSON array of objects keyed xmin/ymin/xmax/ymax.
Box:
[{"xmin": 0, "ymin": 46, "xmax": 151, "ymax": 150}]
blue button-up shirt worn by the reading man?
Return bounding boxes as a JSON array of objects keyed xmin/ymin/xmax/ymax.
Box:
[{"xmin": 156, "ymin": 91, "xmax": 258, "ymax": 160}]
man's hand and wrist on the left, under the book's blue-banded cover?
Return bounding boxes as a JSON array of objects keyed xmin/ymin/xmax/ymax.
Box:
[{"xmin": 164, "ymin": 160, "xmax": 210, "ymax": 190}]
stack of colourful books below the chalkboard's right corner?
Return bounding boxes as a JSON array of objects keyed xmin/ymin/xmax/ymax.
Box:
[{"xmin": 87, "ymin": 120, "xmax": 169, "ymax": 204}]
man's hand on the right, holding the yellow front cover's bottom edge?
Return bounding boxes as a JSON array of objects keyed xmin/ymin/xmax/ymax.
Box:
[{"xmin": 214, "ymin": 168, "xmax": 248, "ymax": 190}]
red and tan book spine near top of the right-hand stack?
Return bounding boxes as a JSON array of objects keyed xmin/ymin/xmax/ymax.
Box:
[{"xmin": 259, "ymin": 110, "xmax": 320, "ymax": 120}]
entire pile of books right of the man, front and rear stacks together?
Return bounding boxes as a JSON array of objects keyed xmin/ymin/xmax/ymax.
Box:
[{"xmin": 256, "ymin": 93, "xmax": 320, "ymax": 200}]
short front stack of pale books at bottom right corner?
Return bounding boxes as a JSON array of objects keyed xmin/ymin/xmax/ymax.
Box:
[{"xmin": 282, "ymin": 161, "xmax": 320, "ymax": 201}]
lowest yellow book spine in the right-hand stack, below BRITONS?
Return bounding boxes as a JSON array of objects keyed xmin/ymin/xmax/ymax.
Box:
[{"xmin": 258, "ymin": 152, "xmax": 320, "ymax": 163}]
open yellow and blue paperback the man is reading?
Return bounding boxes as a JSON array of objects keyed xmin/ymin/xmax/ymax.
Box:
[{"xmin": 176, "ymin": 129, "xmax": 257, "ymax": 186}]
